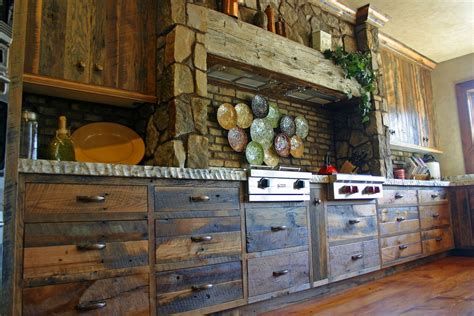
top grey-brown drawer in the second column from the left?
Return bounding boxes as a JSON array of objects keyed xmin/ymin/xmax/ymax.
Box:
[{"xmin": 155, "ymin": 187, "xmax": 240, "ymax": 212}]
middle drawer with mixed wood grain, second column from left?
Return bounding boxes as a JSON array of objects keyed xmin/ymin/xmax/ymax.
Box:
[{"xmin": 155, "ymin": 216, "xmax": 242, "ymax": 264}]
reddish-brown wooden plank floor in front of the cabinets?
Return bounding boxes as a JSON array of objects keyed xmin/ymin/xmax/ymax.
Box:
[{"xmin": 263, "ymin": 257, "xmax": 474, "ymax": 316}]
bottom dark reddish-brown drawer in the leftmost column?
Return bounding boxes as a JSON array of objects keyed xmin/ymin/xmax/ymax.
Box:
[{"xmin": 23, "ymin": 274, "xmax": 150, "ymax": 316}]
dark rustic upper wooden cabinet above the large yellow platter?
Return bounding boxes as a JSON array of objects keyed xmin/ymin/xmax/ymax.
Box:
[{"xmin": 24, "ymin": 0, "xmax": 156, "ymax": 107}]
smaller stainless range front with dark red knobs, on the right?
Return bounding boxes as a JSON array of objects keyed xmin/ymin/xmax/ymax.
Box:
[{"xmin": 329, "ymin": 174, "xmax": 385, "ymax": 200}]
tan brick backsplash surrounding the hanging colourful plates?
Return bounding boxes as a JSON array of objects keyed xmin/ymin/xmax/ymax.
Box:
[{"xmin": 208, "ymin": 84, "xmax": 334, "ymax": 172}]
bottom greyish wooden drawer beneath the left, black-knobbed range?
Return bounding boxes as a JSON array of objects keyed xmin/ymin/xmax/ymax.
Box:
[{"xmin": 248, "ymin": 251, "xmax": 309, "ymax": 296}]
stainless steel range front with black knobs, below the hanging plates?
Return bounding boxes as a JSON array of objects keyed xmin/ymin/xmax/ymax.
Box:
[{"xmin": 248, "ymin": 167, "xmax": 312, "ymax": 202}]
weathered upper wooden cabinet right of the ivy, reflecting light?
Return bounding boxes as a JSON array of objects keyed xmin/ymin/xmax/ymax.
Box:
[{"xmin": 381, "ymin": 48, "xmax": 438, "ymax": 152}]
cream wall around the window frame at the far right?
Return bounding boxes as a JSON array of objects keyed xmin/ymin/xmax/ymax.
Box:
[{"xmin": 431, "ymin": 53, "xmax": 474, "ymax": 176}]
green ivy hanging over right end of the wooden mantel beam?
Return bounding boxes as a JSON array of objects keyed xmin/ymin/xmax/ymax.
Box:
[{"xmin": 323, "ymin": 47, "xmax": 375, "ymax": 123}]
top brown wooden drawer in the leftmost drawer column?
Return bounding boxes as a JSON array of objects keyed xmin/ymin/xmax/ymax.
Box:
[{"xmin": 25, "ymin": 183, "xmax": 147, "ymax": 221}]
